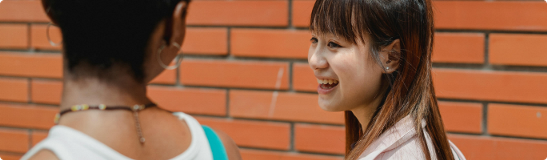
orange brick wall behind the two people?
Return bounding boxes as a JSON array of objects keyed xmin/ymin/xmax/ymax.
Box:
[{"xmin": 0, "ymin": 0, "xmax": 547, "ymax": 160}]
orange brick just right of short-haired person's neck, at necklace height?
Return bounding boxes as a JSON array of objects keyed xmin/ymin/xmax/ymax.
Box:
[{"xmin": 148, "ymin": 86, "xmax": 226, "ymax": 116}]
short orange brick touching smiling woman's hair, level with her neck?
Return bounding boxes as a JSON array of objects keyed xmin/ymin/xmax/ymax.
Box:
[{"xmin": 439, "ymin": 102, "xmax": 482, "ymax": 133}]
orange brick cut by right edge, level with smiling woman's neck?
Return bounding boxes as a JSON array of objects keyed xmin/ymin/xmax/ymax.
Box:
[{"xmin": 487, "ymin": 104, "xmax": 547, "ymax": 139}]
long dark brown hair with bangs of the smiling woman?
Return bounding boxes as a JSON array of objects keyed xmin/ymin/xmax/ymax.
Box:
[{"xmin": 310, "ymin": 0, "xmax": 454, "ymax": 160}]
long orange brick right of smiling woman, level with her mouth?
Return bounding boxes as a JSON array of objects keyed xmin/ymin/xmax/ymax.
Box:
[{"xmin": 433, "ymin": 69, "xmax": 547, "ymax": 103}]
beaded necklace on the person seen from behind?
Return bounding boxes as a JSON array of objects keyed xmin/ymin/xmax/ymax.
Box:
[{"xmin": 54, "ymin": 103, "xmax": 157, "ymax": 144}]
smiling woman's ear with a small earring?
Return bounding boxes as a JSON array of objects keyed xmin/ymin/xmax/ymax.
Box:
[{"xmin": 380, "ymin": 39, "xmax": 401, "ymax": 74}]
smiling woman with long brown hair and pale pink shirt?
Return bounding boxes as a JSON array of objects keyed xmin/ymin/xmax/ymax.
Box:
[{"xmin": 308, "ymin": 0, "xmax": 465, "ymax": 160}]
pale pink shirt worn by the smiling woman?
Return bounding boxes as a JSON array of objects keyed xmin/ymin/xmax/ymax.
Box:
[{"xmin": 358, "ymin": 116, "xmax": 465, "ymax": 160}]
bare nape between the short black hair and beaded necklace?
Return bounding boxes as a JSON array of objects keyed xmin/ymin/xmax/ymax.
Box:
[{"xmin": 60, "ymin": 76, "xmax": 152, "ymax": 110}]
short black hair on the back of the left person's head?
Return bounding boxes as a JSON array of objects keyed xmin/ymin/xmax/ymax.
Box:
[{"xmin": 42, "ymin": 0, "xmax": 189, "ymax": 82}]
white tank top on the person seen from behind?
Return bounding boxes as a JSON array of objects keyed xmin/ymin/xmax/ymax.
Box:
[{"xmin": 21, "ymin": 112, "xmax": 213, "ymax": 160}]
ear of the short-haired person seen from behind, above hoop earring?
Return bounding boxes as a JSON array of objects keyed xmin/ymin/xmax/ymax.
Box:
[{"xmin": 165, "ymin": 1, "xmax": 188, "ymax": 46}]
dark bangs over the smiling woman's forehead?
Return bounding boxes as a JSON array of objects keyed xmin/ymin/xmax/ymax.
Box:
[{"xmin": 310, "ymin": 0, "xmax": 361, "ymax": 43}]
